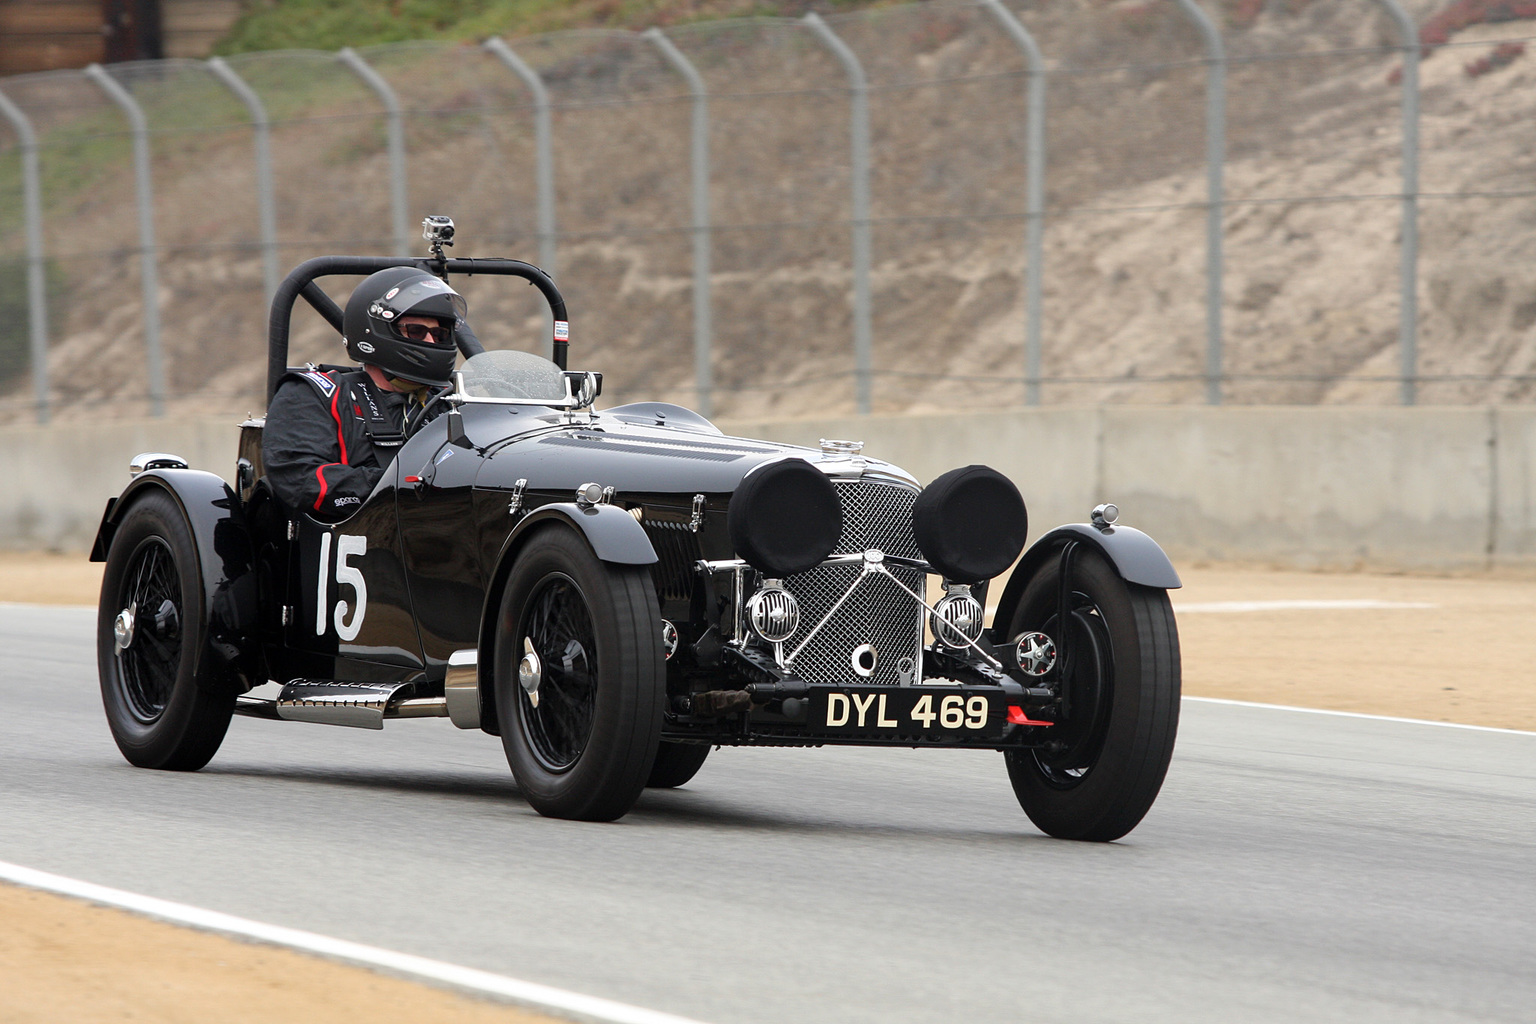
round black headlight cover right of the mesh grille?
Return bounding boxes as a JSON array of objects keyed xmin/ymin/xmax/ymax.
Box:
[{"xmin": 912, "ymin": 465, "xmax": 1029, "ymax": 583}]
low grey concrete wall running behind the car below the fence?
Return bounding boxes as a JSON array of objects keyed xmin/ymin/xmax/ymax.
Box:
[{"xmin": 0, "ymin": 407, "xmax": 1536, "ymax": 570}]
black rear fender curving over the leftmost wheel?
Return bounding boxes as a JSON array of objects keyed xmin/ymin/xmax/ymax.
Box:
[{"xmin": 91, "ymin": 470, "xmax": 260, "ymax": 691}]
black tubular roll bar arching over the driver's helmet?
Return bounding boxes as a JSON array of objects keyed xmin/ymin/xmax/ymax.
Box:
[{"xmin": 267, "ymin": 256, "xmax": 570, "ymax": 404}]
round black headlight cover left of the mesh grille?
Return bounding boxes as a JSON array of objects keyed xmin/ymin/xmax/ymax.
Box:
[{"xmin": 725, "ymin": 459, "xmax": 843, "ymax": 579}]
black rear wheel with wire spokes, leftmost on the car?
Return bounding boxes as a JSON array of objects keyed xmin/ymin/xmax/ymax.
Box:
[{"xmin": 97, "ymin": 490, "xmax": 235, "ymax": 772}]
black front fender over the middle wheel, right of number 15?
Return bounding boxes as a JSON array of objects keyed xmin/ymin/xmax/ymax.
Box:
[{"xmin": 476, "ymin": 502, "xmax": 656, "ymax": 735}]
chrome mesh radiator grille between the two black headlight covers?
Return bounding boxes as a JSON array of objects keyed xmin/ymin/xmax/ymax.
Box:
[{"xmin": 783, "ymin": 479, "xmax": 928, "ymax": 686}]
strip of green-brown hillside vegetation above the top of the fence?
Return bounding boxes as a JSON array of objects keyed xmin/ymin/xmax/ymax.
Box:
[{"xmin": 218, "ymin": 0, "xmax": 892, "ymax": 54}]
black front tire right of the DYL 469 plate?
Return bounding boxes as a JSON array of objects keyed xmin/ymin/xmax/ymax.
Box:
[{"xmin": 1005, "ymin": 545, "xmax": 1180, "ymax": 841}]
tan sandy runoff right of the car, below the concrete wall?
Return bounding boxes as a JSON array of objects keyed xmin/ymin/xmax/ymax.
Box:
[{"xmin": 1174, "ymin": 567, "xmax": 1536, "ymax": 729}]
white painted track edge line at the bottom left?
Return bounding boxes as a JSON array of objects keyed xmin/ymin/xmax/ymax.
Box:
[{"xmin": 0, "ymin": 861, "xmax": 712, "ymax": 1024}]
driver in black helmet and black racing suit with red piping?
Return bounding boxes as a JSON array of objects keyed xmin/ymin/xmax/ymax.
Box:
[{"xmin": 261, "ymin": 267, "xmax": 478, "ymax": 522}]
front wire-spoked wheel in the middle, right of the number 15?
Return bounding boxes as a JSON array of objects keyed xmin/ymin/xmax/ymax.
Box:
[{"xmin": 493, "ymin": 525, "xmax": 667, "ymax": 821}]
